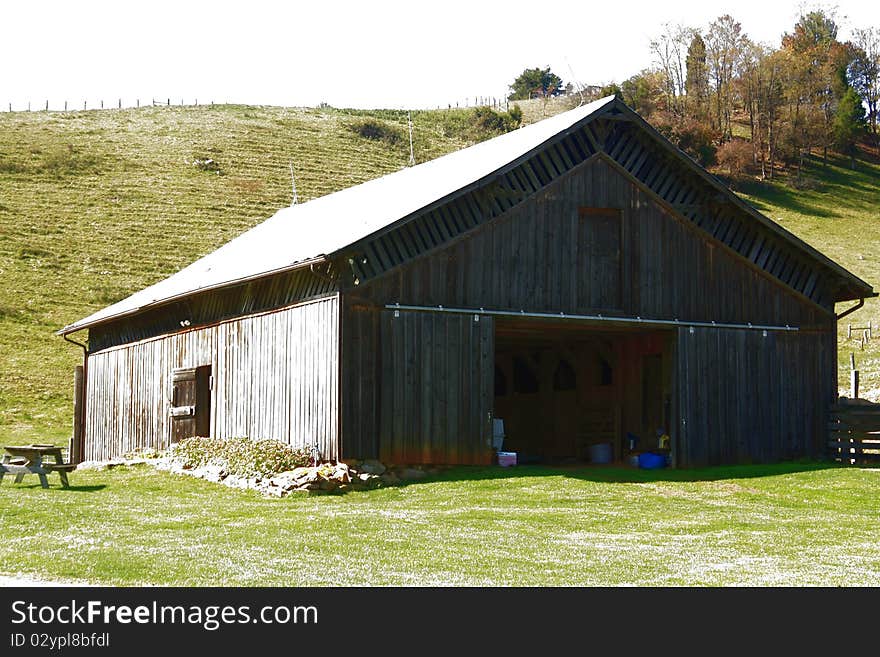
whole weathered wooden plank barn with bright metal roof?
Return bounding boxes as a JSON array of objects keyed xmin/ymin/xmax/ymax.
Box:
[{"xmin": 59, "ymin": 97, "xmax": 875, "ymax": 467}]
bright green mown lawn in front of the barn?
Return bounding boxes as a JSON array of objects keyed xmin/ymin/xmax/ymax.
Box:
[{"xmin": 0, "ymin": 463, "xmax": 880, "ymax": 586}]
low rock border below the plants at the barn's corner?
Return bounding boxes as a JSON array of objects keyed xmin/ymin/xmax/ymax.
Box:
[{"xmin": 155, "ymin": 454, "xmax": 439, "ymax": 497}]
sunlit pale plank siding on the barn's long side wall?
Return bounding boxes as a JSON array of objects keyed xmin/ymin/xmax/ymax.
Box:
[{"xmin": 84, "ymin": 296, "xmax": 339, "ymax": 460}]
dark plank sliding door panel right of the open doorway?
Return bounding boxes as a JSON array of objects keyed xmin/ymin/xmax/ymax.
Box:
[{"xmin": 674, "ymin": 328, "xmax": 837, "ymax": 466}]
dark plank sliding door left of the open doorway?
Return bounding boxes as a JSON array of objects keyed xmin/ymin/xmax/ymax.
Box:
[{"xmin": 379, "ymin": 310, "xmax": 495, "ymax": 464}]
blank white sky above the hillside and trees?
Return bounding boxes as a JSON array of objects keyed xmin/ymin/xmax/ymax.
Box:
[{"xmin": 0, "ymin": 0, "xmax": 880, "ymax": 111}]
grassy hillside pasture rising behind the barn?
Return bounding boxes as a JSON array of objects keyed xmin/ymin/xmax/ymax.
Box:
[{"xmin": 0, "ymin": 101, "xmax": 880, "ymax": 441}]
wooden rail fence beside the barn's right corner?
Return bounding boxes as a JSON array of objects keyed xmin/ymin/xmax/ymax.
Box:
[{"xmin": 828, "ymin": 404, "xmax": 880, "ymax": 465}]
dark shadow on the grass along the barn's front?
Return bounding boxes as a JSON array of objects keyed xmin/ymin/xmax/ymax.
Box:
[{"xmin": 398, "ymin": 461, "xmax": 848, "ymax": 486}]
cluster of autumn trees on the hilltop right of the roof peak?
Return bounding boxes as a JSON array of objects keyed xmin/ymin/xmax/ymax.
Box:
[{"xmin": 607, "ymin": 9, "xmax": 868, "ymax": 182}]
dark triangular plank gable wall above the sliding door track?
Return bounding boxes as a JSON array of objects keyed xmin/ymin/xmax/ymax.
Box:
[{"xmin": 354, "ymin": 157, "xmax": 828, "ymax": 325}]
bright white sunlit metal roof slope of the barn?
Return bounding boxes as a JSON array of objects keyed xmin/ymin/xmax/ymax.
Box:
[{"xmin": 58, "ymin": 96, "xmax": 614, "ymax": 334}]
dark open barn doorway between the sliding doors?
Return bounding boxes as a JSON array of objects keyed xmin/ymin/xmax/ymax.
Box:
[{"xmin": 494, "ymin": 318, "xmax": 674, "ymax": 463}]
